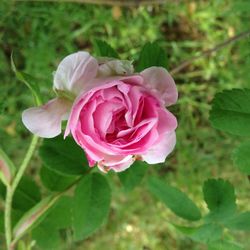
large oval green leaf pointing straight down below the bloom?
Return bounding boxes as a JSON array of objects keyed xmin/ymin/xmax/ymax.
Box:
[{"xmin": 73, "ymin": 173, "xmax": 111, "ymax": 240}]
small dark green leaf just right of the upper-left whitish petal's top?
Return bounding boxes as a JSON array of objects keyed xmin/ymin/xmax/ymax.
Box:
[{"xmin": 93, "ymin": 39, "xmax": 119, "ymax": 58}]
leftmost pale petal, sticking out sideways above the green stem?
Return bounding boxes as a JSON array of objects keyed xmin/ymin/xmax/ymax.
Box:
[{"xmin": 22, "ymin": 98, "xmax": 71, "ymax": 138}]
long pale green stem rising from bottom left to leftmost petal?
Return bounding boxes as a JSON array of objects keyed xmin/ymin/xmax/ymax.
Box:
[{"xmin": 4, "ymin": 136, "xmax": 39, "ymax": 250}]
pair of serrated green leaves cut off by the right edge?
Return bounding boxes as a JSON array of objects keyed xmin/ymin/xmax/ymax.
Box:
[{"xmin": 210, "ymin": 89, "xmax": 250, "ymax": 175}]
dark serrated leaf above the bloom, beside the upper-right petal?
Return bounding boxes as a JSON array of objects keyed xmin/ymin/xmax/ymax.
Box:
[{"xmin": 136, "ymin": 42, "xmax": 168, "ymax": 72}]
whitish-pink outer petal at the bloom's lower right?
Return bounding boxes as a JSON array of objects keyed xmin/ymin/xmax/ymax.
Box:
[{"xmin": 142, "ymin": 132, "xmax": 176, "ymax": 164}]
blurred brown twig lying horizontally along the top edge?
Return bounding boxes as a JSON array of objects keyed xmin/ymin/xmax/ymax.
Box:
[{"xmin": 15, "ymin": 0, "xmax": 167, "ymax": 7}]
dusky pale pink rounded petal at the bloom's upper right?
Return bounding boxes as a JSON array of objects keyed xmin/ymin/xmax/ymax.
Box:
[{"xmin": 141, "ymin": 67, "xmax": 178, "ymax": 106}]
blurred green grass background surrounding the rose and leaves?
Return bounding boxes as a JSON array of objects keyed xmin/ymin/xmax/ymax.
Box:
[{"xmin": 0, "ymin": 0, "xmax": 250, "ymax": 250}]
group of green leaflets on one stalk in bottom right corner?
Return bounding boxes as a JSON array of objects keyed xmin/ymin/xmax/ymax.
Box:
[{"xmin": 148, "ymin": 177, "xmax": 250, "ymax": 250}]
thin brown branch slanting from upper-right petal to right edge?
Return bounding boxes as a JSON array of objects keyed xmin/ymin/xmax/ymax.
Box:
[{"xmin": 170, "ymin": 30, "xmax": 250, "ymax": 75}]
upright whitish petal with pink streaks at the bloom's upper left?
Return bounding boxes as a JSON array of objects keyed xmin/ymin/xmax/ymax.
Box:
[{"xmin": 54, "ymin": 52, "xmax": 98, "ymax": 95}]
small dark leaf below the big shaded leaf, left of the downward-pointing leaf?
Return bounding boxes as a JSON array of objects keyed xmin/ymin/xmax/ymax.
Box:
[{"xmin": 40, "ymin": 167, "xmax": 76, "ymax": 191}]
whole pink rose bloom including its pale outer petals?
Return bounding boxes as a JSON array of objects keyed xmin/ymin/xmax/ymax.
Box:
[{"xmin": 22, "ymin": 52, "xmax": 178, "ymax": 172}]
